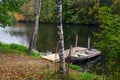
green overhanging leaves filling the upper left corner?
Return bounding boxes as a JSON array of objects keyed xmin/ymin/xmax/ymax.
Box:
[{"xmin": 0, "ymin": 0, "xmax": 25, "ymax": 26}]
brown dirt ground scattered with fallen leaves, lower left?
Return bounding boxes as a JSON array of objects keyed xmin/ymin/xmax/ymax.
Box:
[{"xmin": 0, "ymin": 53, "xmax": 55, "ymax": 80}]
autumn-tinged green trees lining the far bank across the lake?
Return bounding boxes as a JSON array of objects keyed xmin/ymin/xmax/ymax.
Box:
[{"xmin": 0, "ymin": 0, "xmax": 120, "ymax": 25}]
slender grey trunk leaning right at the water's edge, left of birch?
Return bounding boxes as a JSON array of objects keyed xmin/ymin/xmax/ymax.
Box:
[{"xmin": 27, "ymin": 0, "xmax": 41, "ymax": 55}]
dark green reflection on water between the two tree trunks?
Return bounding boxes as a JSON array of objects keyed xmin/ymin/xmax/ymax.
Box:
[{"xmin": 37, "ymin": 24, "xmax": 57, "ymax": 52}]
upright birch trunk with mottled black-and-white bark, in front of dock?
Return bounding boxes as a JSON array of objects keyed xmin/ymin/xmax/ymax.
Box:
[{"xmin": 56, "ymin": 0, "xmax": 66, "ymax": 73}]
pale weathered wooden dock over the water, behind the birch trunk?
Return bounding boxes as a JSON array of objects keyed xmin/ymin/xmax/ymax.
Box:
[{"xmin": 42, "ymin": 47, "xmax": 101, "ymax": 62}]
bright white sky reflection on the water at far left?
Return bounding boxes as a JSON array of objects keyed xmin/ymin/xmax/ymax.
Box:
[{"xmin": 0, "ymin": 27, "xmax": 28, "ymax": 46}]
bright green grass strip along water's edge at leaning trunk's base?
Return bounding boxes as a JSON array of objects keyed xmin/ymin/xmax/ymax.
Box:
[{"xmin": 0, "ymin": 42, "xmax": 41, "ymax": 59}]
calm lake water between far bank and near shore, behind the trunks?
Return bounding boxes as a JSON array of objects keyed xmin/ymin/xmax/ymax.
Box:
[{"xmin": 0, "ymin": 23, "xmax": 95, "ymax": 52}]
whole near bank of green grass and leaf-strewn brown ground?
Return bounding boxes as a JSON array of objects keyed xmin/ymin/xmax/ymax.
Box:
[{"xmin": 0, "ymin": 43, "xmax": 105, "ymax": 80}]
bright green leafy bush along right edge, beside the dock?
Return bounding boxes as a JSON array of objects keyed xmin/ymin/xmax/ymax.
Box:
[{"xmin": 95, "ymin": 6, "xmax": 120, "ymax": 80}]
